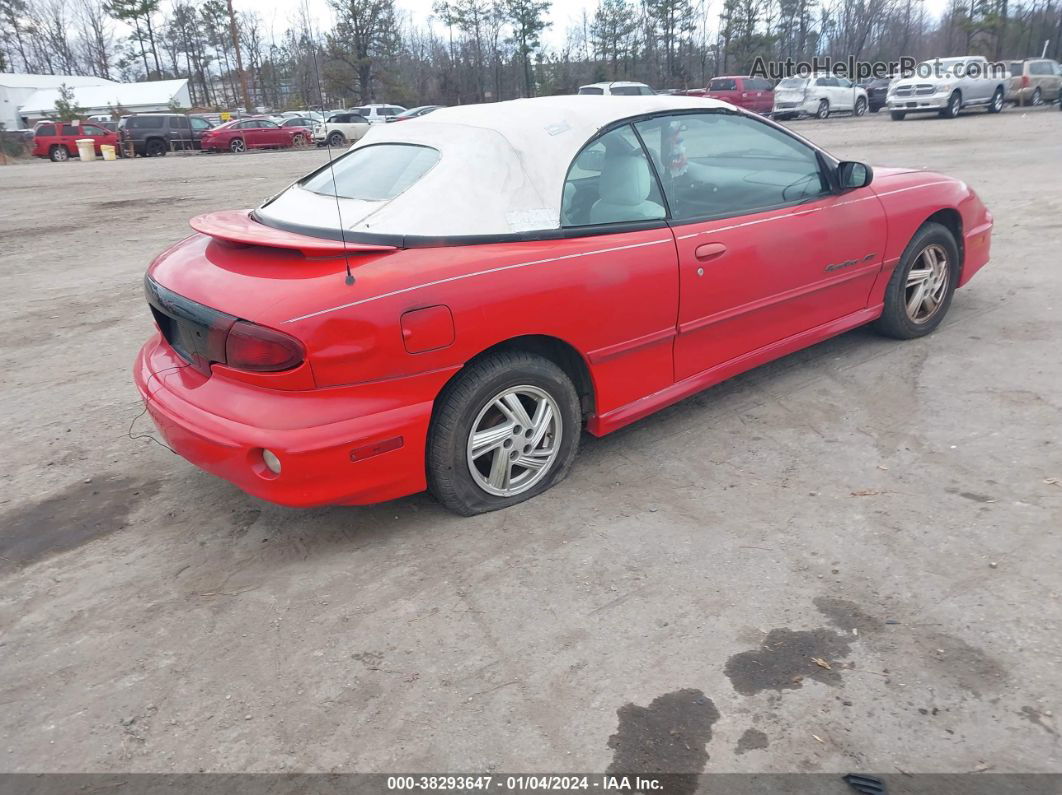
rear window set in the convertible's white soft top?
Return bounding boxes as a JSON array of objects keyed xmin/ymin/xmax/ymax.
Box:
[{"xmin": 302, "ymin": 143, "xmax": 439, "ymax": 202}]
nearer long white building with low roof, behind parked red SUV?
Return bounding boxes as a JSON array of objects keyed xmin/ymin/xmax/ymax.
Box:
[{"xmin": 18, "ymin": 79, "xmax": 191, "ymax": 126}]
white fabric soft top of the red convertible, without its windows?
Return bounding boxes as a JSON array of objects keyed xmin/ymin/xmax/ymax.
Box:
[{"xmin": 255, "ymin": 96, "xmax": 732, "ymax": 237}]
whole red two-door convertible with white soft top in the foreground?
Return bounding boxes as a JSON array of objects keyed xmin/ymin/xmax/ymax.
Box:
[{"xmin": 135, "ymin": 97, "xmax": 992, "ymax": 515}]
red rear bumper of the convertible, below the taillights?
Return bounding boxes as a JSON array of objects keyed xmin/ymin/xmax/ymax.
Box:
[{"xmin": 133, "ymin": 334, "xmax": 448, "ymax": 507}]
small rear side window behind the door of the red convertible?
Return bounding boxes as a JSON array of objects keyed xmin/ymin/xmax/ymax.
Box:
[{"xmin": 561, "ymin": 125, "xmax": 666, "ymax": 226}]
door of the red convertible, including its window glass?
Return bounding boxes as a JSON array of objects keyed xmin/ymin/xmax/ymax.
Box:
[{"xmin": 636, "ymin": 111, "xmax": 886, "ymax": 380}]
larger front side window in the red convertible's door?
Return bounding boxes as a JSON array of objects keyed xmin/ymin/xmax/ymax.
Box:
[{"xmin": 636, "ymin": 113, "xmax": 829, "ymax": 221}]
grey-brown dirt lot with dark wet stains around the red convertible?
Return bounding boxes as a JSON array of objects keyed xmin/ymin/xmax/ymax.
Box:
[{"xmin": 0, "ymin": 107, "xmax": 1062, "ymax": 773}]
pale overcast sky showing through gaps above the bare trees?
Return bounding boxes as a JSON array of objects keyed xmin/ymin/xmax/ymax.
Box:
[{"xmin": 233, "ymin": 0, "xmax": 947, "ymax": 47}]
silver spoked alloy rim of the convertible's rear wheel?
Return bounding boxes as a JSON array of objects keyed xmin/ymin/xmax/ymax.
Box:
[{"xmin": 466, "ymin": 384, "xmax": 562, "ymax": 497}]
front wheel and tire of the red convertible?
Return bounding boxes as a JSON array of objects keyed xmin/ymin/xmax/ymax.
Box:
[{"xmin": 874, "ymin": 222, "xmax": 961, "ymax": 340}]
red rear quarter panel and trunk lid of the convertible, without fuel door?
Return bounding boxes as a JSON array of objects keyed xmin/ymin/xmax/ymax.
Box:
[{"xmin": 149, "ymin": 228, "xmax": 679, "ymax": 418}]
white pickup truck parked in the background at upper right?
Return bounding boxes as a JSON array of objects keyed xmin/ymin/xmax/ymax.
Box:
[{"xmin": 886, "ymin": 55, "xmax": 1007, "ymax": 121}]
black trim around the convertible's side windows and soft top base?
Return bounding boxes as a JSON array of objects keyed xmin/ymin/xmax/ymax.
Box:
[{"xmin": 251, "ymin": 108, "xmax": 843, "ymax": 248}]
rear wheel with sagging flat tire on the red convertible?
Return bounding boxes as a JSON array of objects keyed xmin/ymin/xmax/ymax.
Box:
[{"xmin": 427, "ymin": 351, "xmax": 582, "ymax": 516}]
